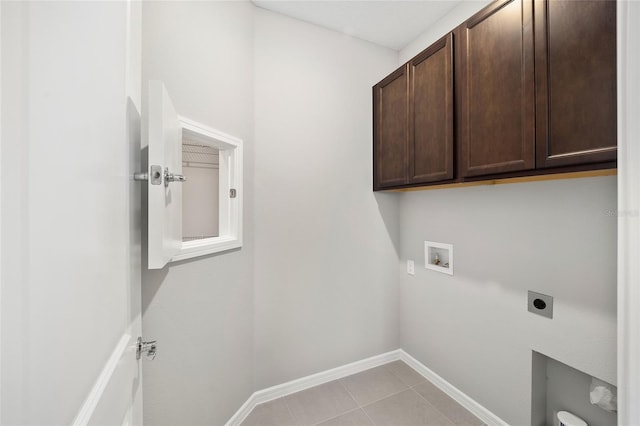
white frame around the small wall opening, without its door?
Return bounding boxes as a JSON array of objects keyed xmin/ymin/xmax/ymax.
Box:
[{"xmin": 171, "ymin": 117, "xmax": 244, "ymax": 262}]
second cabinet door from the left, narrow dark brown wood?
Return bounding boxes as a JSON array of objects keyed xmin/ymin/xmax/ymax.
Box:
[{"xmin": 409, "ymin": 34, "xmax": 453, "ymax": 183}]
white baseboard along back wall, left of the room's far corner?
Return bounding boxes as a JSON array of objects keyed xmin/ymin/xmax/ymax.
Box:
[{"xmin": 226, "ymin": 349, "xmax": 401, "ymax": 426}]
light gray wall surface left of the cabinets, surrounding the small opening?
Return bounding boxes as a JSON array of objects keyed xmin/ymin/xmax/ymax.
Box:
[{"xmin": 143, "ymin": 2, "xmax": 399, "ymax": 424}]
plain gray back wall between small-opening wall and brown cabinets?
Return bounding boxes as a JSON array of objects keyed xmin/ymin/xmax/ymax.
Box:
[{"xmin": 255, "ymin": 9, "xmax": 399, "ymax": 389}]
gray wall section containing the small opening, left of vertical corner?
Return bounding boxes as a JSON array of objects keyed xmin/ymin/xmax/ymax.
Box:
[{"xmin": 142, "ymin": 2, "xmax": 254, "ymax": 425}]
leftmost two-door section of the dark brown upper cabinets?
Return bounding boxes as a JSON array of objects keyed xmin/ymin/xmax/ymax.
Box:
[{"xmin": 373, "ymin": 34, "xmax": 454, "ymax": 189}]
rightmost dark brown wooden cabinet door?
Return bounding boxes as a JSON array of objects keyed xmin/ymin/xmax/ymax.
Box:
[{"xmin": 535, "ymin": 0, "xmax": 617, "ymax": 167}]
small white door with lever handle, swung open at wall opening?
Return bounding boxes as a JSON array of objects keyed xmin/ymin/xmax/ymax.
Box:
[{"xmin": 143, "ymin": 80, "xmax": 182, "ymax": 269}]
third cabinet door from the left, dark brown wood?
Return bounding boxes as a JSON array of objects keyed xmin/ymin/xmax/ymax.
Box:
[{"xmin": 456, "ymin": 0, "xmax": 535, "ymax": 176}]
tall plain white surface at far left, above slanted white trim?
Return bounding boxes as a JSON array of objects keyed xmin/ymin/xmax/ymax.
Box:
[{"xmin": 0, "ymin": 2, "xmax": 140, "ymax": 424}]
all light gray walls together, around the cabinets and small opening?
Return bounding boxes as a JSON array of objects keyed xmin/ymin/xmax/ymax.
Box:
[{"xmin": 138, "ymin": 2, "xmax": 616, "ymax": 424}]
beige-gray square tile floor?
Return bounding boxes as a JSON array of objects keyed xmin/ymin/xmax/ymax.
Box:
[{"xmin": 242, "ymin": 361, "xmax": 483, "ymax": 426}]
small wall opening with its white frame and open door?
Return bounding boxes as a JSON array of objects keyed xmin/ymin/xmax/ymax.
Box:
[{"xmin": 146, "ymin": 80, "xmax": 244, "ymax": 269}]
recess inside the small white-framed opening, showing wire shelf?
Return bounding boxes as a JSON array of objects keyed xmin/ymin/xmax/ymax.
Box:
[{"xmin": 182, "ymin": 141, "xmax": 220, "ymax": 242}]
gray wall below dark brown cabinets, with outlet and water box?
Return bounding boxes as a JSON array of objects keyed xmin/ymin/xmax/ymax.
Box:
[{"xmin": 400, "ymin": 176, "xmax": 616, "ymax": 424}]
